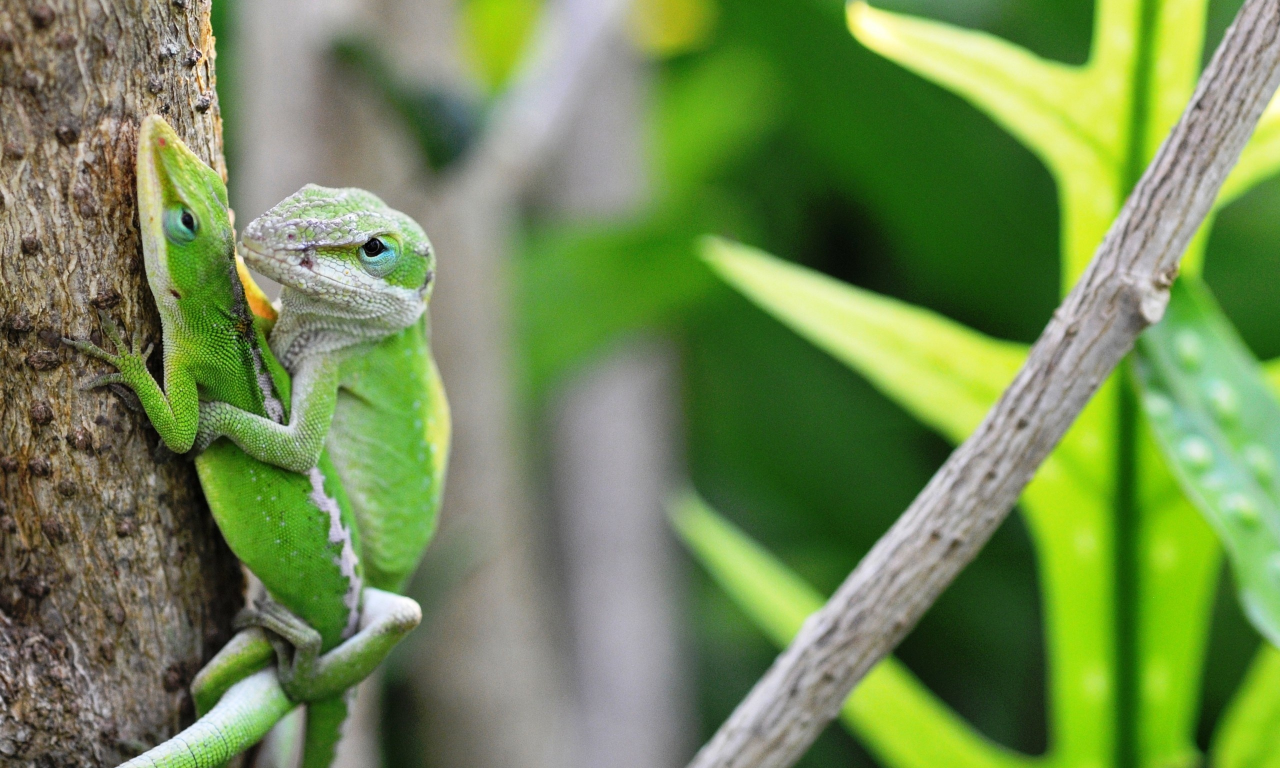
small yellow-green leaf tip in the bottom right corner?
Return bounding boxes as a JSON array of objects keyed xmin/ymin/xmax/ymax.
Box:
[{"xmin": 1210, "ymin": 643, "xmax": 1280, "ymax": 768}]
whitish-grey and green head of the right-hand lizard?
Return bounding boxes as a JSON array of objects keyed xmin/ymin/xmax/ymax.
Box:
[{"xmin": 241, "ymin": 184, "xmax": 435, "ymax": 326}]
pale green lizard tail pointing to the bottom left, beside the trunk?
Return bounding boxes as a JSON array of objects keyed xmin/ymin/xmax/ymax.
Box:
[{"xmin": 119, "ymin": 667, "xmax": 293, "ymax": 768}]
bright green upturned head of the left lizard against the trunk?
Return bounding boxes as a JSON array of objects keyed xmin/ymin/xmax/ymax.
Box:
[{"xmin": 137, "ymin": 115, "xmax": 236, "ymax": 310}]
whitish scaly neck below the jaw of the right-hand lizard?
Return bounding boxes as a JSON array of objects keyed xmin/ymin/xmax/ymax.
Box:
[{"xmin": 271, "ymin": 287, "xmax": 426, "ymax": 372}]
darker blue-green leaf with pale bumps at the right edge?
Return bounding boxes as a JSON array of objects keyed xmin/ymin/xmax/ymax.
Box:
[{"xmin": 1134, "ymin": 276, "xmax": 1280, "ymax": 643}]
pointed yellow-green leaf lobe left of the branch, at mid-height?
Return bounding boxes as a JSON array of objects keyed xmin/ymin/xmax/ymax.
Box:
[{"xmin": 703, "ymin": 238, "xmax": 1027, "ymax": 443}]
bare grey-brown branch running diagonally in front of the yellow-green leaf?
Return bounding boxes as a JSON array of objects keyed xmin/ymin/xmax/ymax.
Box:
[{"xmin": 690, "ymin": 0, "xmax": 1280, "ymax": 768}]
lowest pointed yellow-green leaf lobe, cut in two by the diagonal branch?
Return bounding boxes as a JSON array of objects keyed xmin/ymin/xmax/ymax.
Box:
[{"xmin": 671, "ymin": 492, "xmax": 1038, "ymax": 768}]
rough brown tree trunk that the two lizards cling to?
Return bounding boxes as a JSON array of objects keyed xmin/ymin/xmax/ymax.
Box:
[{"xmin": 0, "ymin": 0, "xmax": 241, "ymax": 765}]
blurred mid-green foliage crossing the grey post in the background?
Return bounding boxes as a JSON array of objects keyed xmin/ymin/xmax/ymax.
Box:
[{"xmin": 515, "ymin": 49, "xmax": 776, "ymax": 396}]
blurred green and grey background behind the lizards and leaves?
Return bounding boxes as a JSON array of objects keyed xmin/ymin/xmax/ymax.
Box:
[{"xmin": 214, "ymin": 0, "xmax": 1280, "ymax": 768}]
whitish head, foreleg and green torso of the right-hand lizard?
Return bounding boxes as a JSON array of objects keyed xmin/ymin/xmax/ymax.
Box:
[{"xmin": 196, "ymin": 184, "xmax": 449, "ymax": 591}]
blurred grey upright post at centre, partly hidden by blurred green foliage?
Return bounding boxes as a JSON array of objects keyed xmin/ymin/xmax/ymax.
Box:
[{"xmin": 536, "ymin": 36, "xmax": 692, "ymax": 768}]
